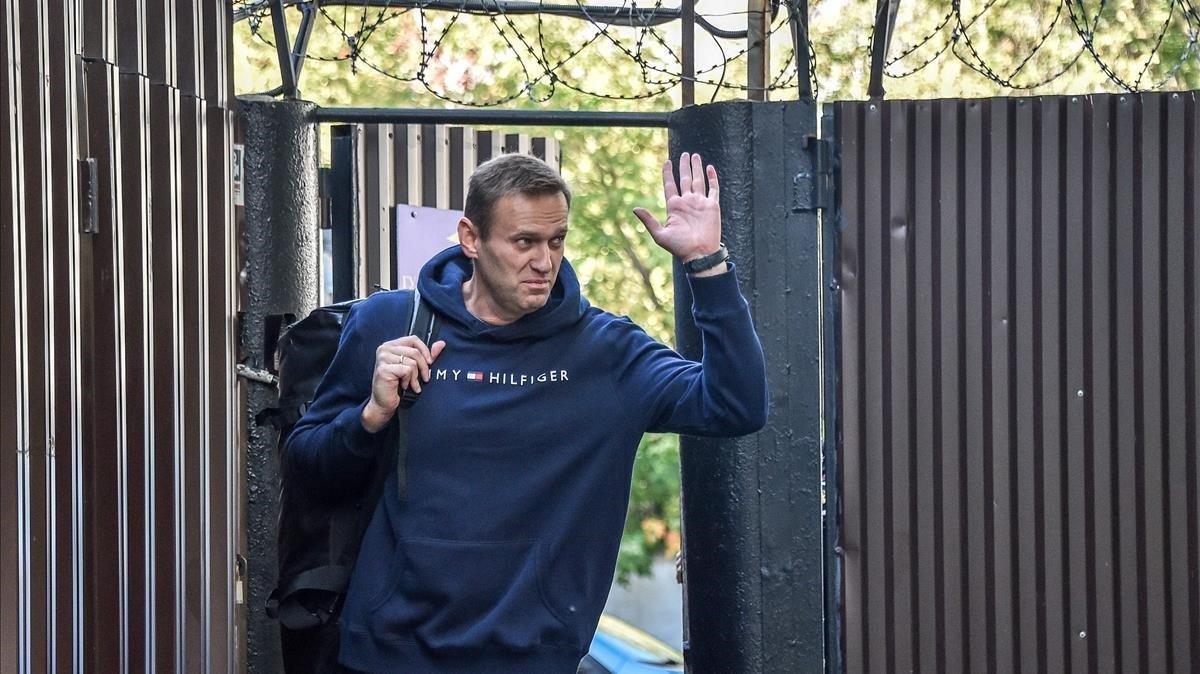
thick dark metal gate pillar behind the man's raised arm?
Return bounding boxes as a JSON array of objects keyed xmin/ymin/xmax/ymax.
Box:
[{"xmin": 670, "ymin": 101, "xmax": 824, "ymax": 673}]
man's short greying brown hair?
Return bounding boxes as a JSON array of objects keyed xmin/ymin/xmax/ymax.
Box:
[{"xmin": 463, "ymin": 154, "xmax": 571, "ymax": 239}]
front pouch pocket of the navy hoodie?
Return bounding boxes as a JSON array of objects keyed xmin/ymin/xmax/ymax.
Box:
[{"xmin": 371, "ymin": 538, "xmax": 578, "ymax": 650}]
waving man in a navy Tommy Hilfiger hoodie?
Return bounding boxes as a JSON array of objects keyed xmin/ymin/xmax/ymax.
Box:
[{"xmin": 286, "ymin": 154, "xmax": 767, "ymax": 674}]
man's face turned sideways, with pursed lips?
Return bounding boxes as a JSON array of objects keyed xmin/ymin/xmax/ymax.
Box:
[{"xmin": 458, "ymin": 192, "xmax": 568, "ymax": 320}]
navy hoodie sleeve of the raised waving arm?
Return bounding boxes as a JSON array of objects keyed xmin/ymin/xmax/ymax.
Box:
[{"xmin": 616, "ymin": 269, "xmax": 767, "ymax": 437}]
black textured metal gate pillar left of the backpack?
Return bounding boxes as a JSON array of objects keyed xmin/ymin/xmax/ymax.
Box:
[{"xmin": 238, "ymin": 96, "xmax": 320, "ymax": 674}]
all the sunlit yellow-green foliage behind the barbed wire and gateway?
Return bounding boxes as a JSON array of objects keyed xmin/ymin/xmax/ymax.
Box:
[{"xmin": 234, "ymin": 0, "xmax": 1200, "ymax": 579}]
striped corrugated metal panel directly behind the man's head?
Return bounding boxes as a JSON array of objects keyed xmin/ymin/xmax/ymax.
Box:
[{"xmin": 356, "ymin": 124, "xmax": 562, "ymax": 293}]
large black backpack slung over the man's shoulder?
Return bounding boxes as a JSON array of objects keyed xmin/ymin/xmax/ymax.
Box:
[{"xmin": 257, "ymin": 290, "xmax": 437, "ymax": 674}]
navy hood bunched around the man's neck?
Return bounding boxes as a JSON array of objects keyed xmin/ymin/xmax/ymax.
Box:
[{"xmin": 416, "ymin": 246, "xmax": 588, "ymax": 342}]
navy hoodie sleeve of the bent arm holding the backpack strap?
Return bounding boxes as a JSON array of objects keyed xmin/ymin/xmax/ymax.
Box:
[{"xmin": 283, "ymin": 296, "xmax": 390, "ymax": 498}]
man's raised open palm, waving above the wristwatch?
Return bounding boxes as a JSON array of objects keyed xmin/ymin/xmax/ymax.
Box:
[{"xmin": 634, "ymin": 152, "xmax": 721, "ymax": 261}]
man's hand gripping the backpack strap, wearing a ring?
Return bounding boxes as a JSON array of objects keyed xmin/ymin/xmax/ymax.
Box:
[{"xmin": 362, "ymin": 335, "xmax": 446, "ymax": 433}]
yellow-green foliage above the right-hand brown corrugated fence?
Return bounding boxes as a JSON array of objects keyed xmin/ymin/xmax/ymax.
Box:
[{"xmin": 810, "ymin": 0, "xmax": 1200, "ymax": 101}]
